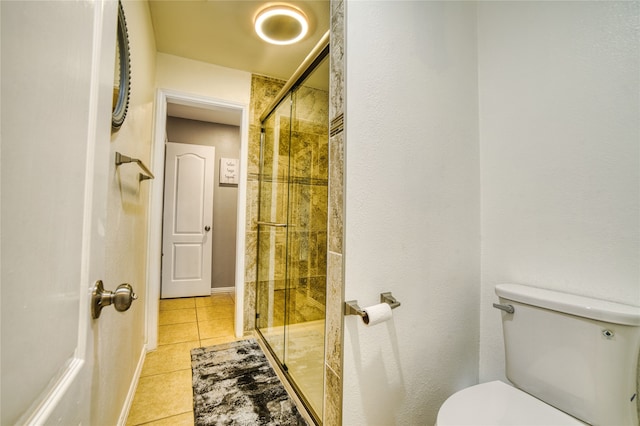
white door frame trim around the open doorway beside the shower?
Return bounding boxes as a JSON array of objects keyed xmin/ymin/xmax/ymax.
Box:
[{"xmin": 147, "ymin": 88, "xmax": 249, "ymax": 350}]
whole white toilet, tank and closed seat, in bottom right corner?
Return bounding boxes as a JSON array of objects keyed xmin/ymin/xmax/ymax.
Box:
[{"xmin": 437, "ymin": 284, "xmax": 640, "ymax": 426}]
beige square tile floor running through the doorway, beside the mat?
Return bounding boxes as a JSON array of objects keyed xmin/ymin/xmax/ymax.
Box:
[{"xmin": 127, "ymin": 293, "xmax": 237, "ymax": 426}]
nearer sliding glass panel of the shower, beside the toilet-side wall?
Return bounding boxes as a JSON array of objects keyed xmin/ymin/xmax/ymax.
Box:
[{"xmin": 284, "ymin": 72, "xmax": 329, "ymax": 413}]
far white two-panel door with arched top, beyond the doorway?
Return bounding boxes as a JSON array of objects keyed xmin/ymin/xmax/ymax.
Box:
[{"xmin": 161, "ymin": 142, "xmax": 215, "ymax": 298}]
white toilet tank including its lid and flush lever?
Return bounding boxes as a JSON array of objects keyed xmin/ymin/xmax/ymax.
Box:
[{"xmin": 495, "ymin": 284, "xmax": 640, "ymax": 426}]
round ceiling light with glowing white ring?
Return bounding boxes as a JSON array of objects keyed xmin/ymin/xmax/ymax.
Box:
[{"xmin": 255, "ymin": 6, "xmax": 309, "ymax": 44}]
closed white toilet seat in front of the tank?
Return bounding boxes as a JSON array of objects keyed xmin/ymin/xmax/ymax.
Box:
[{"xmin": 436, "ymin": 381, "xmax": 586, "ymax": 426}]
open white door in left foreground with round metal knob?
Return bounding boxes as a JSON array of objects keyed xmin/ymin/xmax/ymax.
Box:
[{"xmin": 0, "ymin": 0, "xmax": 115, "ymax": 425}]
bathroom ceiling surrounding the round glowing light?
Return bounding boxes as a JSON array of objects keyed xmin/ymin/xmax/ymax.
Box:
[{"xmin": 149, "ymin": 0, "xmax": 330, "ymax": 80}]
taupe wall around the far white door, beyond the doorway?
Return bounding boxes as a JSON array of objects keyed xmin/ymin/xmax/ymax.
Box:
[{"xmin": 167, "ymin": 117, "xmax": 240, "ymax": 288}]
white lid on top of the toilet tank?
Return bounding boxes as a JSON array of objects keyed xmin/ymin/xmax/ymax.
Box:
[{"xmin": 495, "ymin": 284, "xmax": 640, "ymax": 327}]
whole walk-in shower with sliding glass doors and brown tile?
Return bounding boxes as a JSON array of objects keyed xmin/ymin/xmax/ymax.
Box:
[{"xmin": 256, "ymin": 37, "xmax": 329, "ymax": 423}]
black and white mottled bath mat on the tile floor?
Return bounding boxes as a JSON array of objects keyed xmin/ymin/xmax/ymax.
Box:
[{"xmin": 191, "ymin": 339, "xmax": 308, "ymax": 426}]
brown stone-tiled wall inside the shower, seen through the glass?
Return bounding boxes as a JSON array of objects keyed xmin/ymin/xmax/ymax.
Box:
[{"xmin": 256, "ymin": 84, "xmax": 329, "ymax": 327}]
